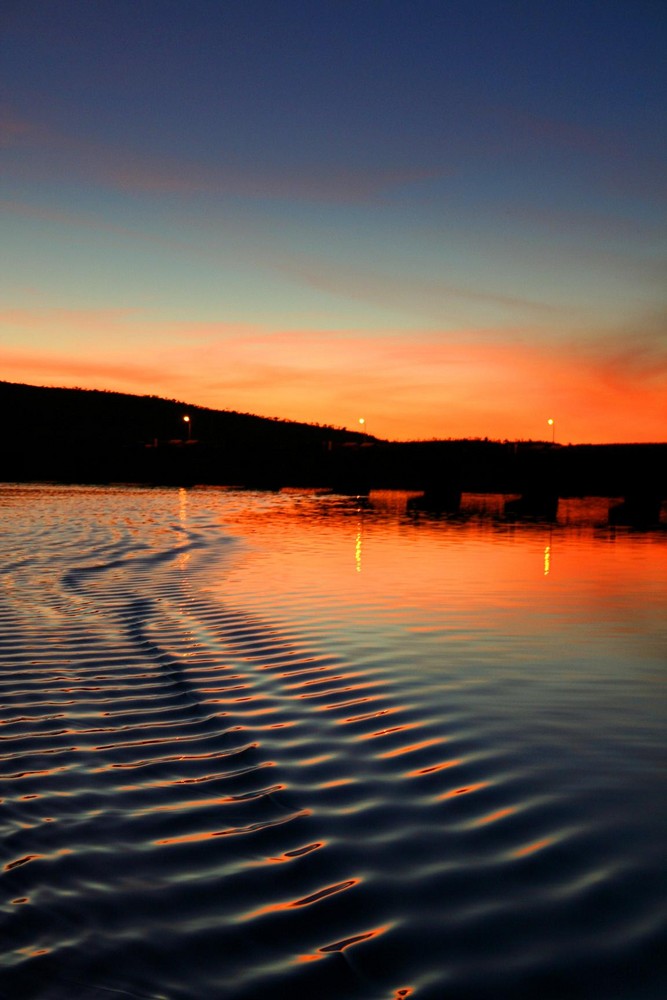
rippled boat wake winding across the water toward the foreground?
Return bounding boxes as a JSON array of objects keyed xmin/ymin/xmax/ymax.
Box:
[{"xmin": 0, "ymin": 488, "xmax": 663, "ymax": 1000}]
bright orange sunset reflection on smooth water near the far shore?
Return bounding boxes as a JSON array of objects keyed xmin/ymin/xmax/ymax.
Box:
[{"xmin": 212, "ymin": 493, "xmax": 665, "ymax": 640}]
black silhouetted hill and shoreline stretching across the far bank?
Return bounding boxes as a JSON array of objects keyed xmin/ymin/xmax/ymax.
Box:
[{"xmin": 0, "ymin": 382, "xmax": 667, "ymax": 511}]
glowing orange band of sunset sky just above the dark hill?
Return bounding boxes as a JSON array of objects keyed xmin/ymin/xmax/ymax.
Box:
[{"xmin": 0, "ymin": 309, "xmax": 667, "ymax": 444}]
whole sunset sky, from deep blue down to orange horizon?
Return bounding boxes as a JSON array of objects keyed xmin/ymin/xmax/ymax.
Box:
[{"xmin": 0, "ymin": 0, "xmax": 667, "ymax": 444}]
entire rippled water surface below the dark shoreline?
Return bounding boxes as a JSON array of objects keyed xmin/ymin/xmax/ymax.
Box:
[{"xmin": 0, "ymin": 486, "xmax": 667, "ymax": 1000}]
